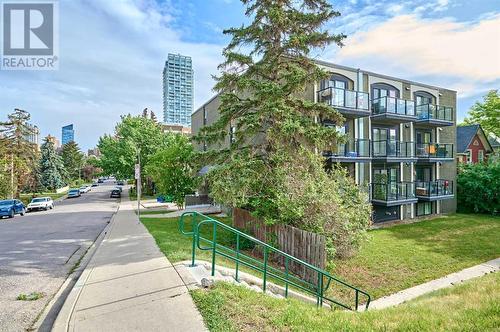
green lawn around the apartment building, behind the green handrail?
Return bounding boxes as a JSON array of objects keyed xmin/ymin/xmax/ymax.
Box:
[{"xmin": 141, "ymin": 214, "xmax": 500, "ymax": 303}]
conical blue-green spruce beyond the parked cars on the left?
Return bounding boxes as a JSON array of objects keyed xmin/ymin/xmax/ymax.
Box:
[{"xmin": 39, "ymin": 138, "xmax": 65, "ymax": 190}]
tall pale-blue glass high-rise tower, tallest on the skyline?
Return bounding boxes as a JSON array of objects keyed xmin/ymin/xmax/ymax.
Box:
[{"xmin": 163, "ymin": 54, "xmax": 194, "ymax": 127}]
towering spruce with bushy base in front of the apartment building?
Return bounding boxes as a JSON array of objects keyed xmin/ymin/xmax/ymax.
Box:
[{"xmin": 195, "ymin": 0, "xmax": 369, "ymax": 256}]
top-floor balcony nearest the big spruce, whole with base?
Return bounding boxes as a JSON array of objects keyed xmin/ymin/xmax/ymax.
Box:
[{"xmin": 318, "ymin": 87, "xmax": 370, "ymax": 118}]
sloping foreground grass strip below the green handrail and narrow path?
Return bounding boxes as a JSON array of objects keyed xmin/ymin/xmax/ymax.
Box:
[{"xmin": 191, "ymin": 273, "xmax": 500, "ymax": 332}]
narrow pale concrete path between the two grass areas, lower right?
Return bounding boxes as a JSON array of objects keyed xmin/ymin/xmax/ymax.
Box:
[{"xmin": 369, "ymin": 258, "xmax": 500, "ymax": 310}]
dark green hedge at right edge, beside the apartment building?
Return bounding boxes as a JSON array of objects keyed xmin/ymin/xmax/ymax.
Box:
[{"xmin": 457, "ymin": 159, "xmax": 500, "ymax": 215}]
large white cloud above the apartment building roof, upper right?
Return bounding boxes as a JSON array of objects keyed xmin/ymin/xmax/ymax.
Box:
[{"xmin": 335, "ymin": 14, "xmax": 500, "ymax": 96}]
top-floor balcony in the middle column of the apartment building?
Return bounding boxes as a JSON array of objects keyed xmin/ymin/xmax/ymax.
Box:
[{"xmin": 372, "ymin": 96, "xmax": 416, "ymax": 124}]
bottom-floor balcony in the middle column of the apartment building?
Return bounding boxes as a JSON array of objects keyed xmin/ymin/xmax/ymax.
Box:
[{"xmin": 371, "ymin": 182, "xmax": 418, "ymax": 206}]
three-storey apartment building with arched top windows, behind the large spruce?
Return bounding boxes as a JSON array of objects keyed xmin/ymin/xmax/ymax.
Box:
[{"xmin": 192, "ymin": 61, "xmax": 457, "ymax": 222}]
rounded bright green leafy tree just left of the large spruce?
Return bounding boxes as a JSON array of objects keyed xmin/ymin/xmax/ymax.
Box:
[{"xmin": 145, "ymin": 134, "xmax": 199, "ymax": 207}]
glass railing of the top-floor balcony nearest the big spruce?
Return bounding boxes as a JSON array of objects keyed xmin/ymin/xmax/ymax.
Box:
[{"xmin": 318, "ymin": 87, "xmax": 370, "ymax": 111}]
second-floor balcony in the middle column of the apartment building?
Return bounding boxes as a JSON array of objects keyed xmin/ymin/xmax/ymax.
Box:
[{"xmin": 372, "ymin": 139, "xmax": 416, "ymax": 162}]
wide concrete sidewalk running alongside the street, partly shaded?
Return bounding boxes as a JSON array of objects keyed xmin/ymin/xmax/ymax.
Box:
[{"xmin": 53, "ymin": 192, "xmax": 207, "ymax": 332}]
